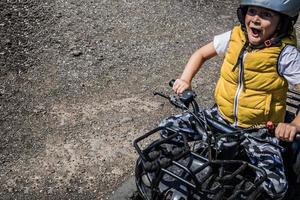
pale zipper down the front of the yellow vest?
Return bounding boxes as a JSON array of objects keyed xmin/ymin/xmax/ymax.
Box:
[{"xmin": 233, "ymin": 45, "xmax": 247, "ymax": 126}]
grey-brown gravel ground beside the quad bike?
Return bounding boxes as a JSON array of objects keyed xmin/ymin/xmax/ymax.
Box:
[{"xmin": 0, "ymin": 0, "xmax": 299, "ymax": 199}]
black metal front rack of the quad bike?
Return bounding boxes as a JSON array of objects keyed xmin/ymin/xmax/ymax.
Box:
[{"xmin": 134, "ymin": 127, "xmax": 267, "ymax": 200}]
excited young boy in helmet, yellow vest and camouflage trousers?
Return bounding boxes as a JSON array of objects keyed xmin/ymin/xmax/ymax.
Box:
[{"xmin": 169, "ymin": 0, "xmax": 300, "ymax": 199}]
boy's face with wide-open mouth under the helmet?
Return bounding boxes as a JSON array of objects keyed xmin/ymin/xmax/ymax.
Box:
[{"xmin": 245, "ymin": 6, "xmax": 280, "ymax": 45}]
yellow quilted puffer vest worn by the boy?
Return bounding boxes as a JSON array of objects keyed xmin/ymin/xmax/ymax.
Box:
[{"xmin": 215, "ymin": 26, "xmax": 297, "ymax": 127}]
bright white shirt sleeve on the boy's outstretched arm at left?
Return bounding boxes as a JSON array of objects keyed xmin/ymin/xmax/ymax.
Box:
[{"xmin": 213, "ymin": 31, "xmax": 231, "ymax": 56}]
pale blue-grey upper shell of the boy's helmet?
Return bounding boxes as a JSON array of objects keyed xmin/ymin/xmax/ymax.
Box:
[{"xmin": 240, "ymin": 0, "xmax": 300, "ymax": 18}]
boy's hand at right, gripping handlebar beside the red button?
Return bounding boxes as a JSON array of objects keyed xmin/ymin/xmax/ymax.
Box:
[{"xmin": 275, "ymin": 123, "xmax": 297, "ymax": 142}]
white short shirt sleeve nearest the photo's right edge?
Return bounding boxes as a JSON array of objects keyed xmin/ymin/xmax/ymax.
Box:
[{"xmin": 278, "ymin": 45, "xmax": 300, "ymax": 85}]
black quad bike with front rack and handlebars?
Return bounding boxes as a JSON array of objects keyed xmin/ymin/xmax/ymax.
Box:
[{"xmin": 133, "ymin": 80, "xmax": 300, "ymax": 200}]
